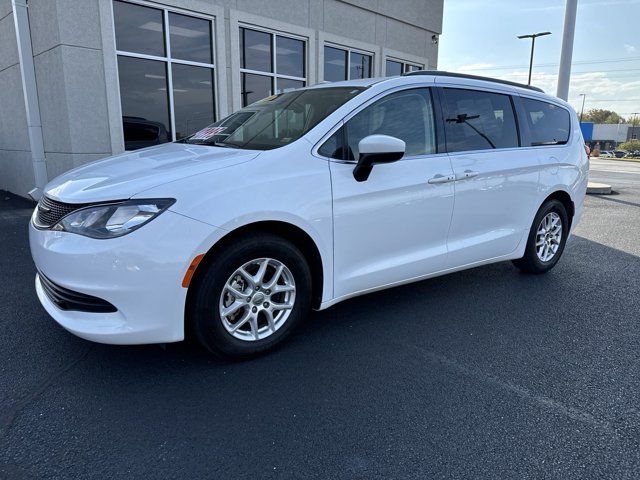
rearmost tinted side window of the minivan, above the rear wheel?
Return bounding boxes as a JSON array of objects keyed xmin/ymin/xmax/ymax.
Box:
[{"xmin": 522, "ymin": 98, "xmax": 571, "ymax": 147}]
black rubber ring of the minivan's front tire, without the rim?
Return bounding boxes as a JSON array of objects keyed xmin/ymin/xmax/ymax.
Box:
[{"xmin": 190, "ymin": 234, "xmax": 311, "ymax": 358}]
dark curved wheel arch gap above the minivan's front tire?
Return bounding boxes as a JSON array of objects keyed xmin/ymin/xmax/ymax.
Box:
[{"xmin": 185, "ymin": 220, "xmax": 325, "ymax": 314}]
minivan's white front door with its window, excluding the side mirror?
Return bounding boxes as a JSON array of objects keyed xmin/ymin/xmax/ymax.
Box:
[{"xmin": 319, "ymin": 88, "xmax": 454, "ymax": 298}]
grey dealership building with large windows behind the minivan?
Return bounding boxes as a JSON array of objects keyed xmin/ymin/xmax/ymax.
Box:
[{"xmin": 0, "ymin": 0, "xmax": 443, "ymax": 196}]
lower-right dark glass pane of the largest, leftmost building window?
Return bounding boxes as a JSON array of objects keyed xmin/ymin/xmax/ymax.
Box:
[{"xmin": 171, "ymin": 63, "xmax": 215, "ymax": 140}]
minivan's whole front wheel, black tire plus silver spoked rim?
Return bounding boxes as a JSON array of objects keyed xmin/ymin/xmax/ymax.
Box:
[{"xmin": 188, "ymin": 234, "xmax": 311, "ymax": 359}]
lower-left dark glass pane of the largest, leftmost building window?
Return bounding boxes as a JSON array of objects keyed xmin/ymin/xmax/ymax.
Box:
[{"xmin": 118, "ymin": 57, "xmax": 171, "ymax": 150}]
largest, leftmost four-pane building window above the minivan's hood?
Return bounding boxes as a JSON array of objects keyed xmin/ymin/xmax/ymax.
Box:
[{"xmin": 113, "ymin": 0, "xmax": 215, "ymax": 150}]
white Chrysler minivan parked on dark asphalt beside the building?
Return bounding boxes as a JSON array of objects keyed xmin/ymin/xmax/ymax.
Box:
[{"xmin": 29, "ymin": 71, "xmax": 589, "ymax": 358}]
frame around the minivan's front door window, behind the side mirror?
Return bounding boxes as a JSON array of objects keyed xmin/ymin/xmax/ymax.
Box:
[{"xmin": 311, "ymin": 84, "xmax": 447, "ymax": 165}]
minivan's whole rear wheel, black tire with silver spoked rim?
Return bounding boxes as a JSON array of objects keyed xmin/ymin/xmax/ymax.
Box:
[{"xmin": 513, "ymin": 200, "xmax": 570, "ymax": 274}]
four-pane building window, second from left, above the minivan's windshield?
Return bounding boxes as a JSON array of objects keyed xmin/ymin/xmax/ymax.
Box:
[{"xmin": 240, "ymin": 27, "xmax": 307, "ymax": 107}]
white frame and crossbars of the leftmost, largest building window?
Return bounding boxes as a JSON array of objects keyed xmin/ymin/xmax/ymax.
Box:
[{"xmin": 110, "ymin": 0, "xmax": 220, "ymax": 144}]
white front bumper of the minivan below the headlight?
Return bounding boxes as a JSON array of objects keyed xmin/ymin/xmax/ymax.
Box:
[{"xmin": 29, "ymin": 211, "xmax": 220, "ymax": 345}]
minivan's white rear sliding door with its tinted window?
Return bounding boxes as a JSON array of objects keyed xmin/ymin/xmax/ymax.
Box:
[{"xmin": 439, "ymin": 87, "xmax": 539, "ymax": 267}]
